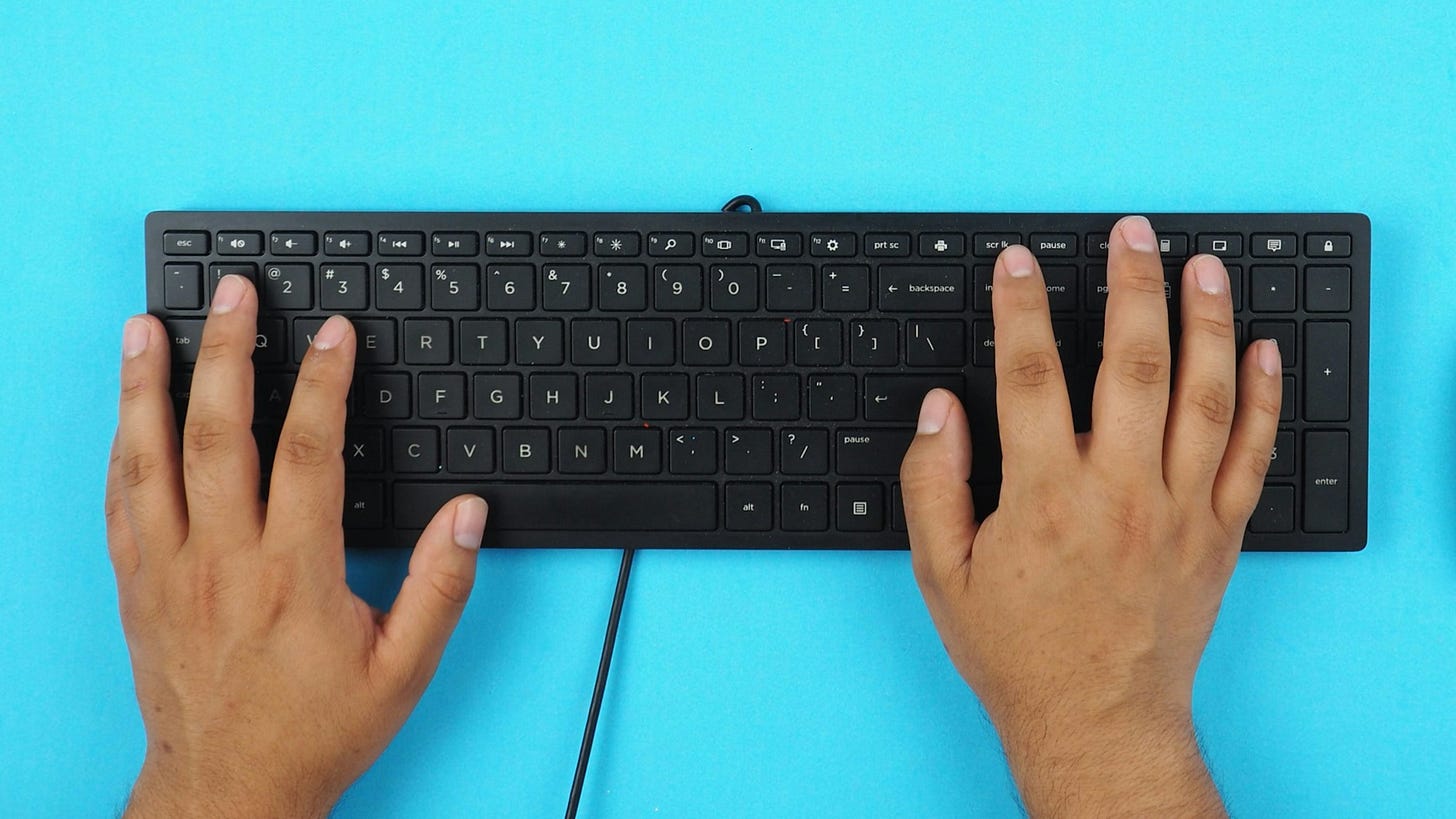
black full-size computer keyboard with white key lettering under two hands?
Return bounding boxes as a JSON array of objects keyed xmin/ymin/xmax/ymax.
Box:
[{"xmin": 146, "ymin": 211, "xmax": 1370, "ymax": 551}]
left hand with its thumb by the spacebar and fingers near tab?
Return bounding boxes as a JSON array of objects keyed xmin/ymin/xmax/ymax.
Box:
[{"xmin": 106, "ymin": 275, "xmax": 486, "ymax": 816}]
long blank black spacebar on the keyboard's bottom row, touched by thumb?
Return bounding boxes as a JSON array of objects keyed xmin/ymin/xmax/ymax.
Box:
[{"xmin": 395, "ymin": 481, "xmax": 718, "ymax": 532}]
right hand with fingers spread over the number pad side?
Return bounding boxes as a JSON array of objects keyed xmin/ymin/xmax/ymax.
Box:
[{"xmin": 901, "ymin": 217, "xmax": 1281, "ymax": 816}]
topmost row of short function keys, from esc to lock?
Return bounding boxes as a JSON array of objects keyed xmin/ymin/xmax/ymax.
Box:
[{"xmin": 162, "ymin": 230, "xmax": 1351, "ymax": 258}]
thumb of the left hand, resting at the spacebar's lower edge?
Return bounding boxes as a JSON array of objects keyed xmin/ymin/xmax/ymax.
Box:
[{"xmin": 377, "ymin": 495, "xmax": 488, "ymax": 689}]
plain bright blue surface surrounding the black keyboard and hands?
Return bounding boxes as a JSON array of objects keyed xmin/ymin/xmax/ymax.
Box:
[{"xmin": 0, "ymin": 0, "xmax": 1456, "ymax": 816}]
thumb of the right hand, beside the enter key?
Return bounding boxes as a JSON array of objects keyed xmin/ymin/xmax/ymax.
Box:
[{"xmin": 900, "ymin": 389, "xmax": 976, "ymax": 589}]
